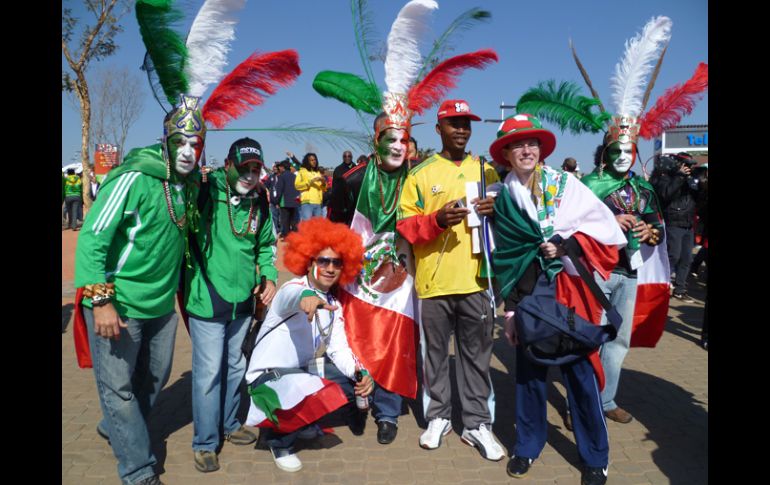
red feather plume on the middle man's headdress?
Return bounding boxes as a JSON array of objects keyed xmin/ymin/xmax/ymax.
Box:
[{"xmin": 408, "ymin": 49, "xmax": 498, "ymax": 114}]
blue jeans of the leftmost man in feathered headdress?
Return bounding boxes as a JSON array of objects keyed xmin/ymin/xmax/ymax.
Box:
[{"xmin": 83, "ymin": 308, "xmax": 179, "ymax": 485}]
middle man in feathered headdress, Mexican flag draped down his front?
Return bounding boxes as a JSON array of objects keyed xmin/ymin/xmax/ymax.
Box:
[{"xmin": 313, "ymin": 0, "xmax": 497, "ymax": 444}]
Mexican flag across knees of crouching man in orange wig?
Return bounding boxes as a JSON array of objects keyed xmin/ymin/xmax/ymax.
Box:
[{"xmin": 246, "ymin": 373, "xmax": 348, "ymax": 433}]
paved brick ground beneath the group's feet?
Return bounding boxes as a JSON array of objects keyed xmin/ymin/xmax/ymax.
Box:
[{"xmin": 62, "ymin": 231, "xmax": 708, "ymax": 485}]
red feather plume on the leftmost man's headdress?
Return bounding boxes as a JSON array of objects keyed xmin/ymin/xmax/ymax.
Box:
[{"xmin": 203, "ymin": 49, "xmax": 302, "ymax": 128}]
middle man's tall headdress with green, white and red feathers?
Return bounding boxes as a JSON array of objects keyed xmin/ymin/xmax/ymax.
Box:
[{"xmin": 313, "ymin": 0, "xmax": 498, "ymax": 142}]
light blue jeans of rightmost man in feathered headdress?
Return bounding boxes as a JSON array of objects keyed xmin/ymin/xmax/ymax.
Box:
[{"xmin": 594, "ymin": 273, "xmax": 636, "ymax": 411}]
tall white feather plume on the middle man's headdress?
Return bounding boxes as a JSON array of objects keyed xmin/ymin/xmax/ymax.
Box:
[{"xmin": 385, "ymin": 0, "xmax": 438, "ymax": 93}]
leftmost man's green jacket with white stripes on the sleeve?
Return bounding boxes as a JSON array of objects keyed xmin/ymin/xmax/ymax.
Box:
[{"xmin": 75, "ymin": 144, "xmax": 198, "ymax": 318}]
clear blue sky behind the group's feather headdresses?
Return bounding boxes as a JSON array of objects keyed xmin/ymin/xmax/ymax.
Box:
[{"xmin": 62, "ymin": 0, "xmax": 708, "ymax": 172}]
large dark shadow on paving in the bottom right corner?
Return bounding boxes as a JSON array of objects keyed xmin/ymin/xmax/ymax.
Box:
[{"xmin": 622, "ymin": 369, "xmax": 708, "ymax": 485}]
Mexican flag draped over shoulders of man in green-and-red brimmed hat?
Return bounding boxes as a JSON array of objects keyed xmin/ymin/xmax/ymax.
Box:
[{"xmin": 493, "ymin": 168, "xmax": 626, "ymax": 388}]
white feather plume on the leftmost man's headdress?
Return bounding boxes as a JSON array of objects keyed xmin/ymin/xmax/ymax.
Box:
[{"xmin": 185, "ymin": 0, "xmax": 246, "ymax": 96}]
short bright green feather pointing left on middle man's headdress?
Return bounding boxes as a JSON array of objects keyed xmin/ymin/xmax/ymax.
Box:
[{"xmin": 313, "ymin": 71, "xmax": 382, "ymax": 115}]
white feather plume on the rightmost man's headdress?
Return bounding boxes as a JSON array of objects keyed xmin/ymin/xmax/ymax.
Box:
[{"xmin": 610, "ymin": 16, "xmax": 671, "ymax": 116}]
